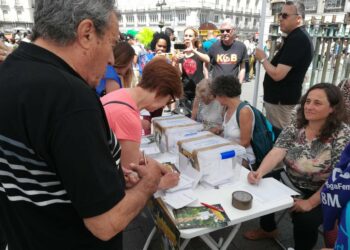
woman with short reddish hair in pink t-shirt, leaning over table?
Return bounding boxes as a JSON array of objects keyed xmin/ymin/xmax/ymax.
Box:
[{"xmin": 101, "ymin": 57, "xmax": 182, "ymax": 189}]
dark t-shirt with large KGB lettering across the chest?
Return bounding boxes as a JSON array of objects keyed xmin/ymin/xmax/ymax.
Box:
[{"xmin": 209, "ymin": 40, "xmax": 248, "ymax": 79}]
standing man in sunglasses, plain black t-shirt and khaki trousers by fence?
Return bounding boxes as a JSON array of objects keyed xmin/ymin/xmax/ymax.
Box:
[{"xmin": 255, "ymin": 1, "xmax": 314, "ymax": 128}]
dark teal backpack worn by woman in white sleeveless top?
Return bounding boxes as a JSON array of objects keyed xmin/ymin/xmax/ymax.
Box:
[{"xmin": 236, "ymin": 101, "xmax": 280, "ymax": 168}]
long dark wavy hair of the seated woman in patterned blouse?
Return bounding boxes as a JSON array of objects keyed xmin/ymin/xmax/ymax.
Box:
[{"xmin": 296, "ymin": 83, "xmax": 347, "ymax": 141}]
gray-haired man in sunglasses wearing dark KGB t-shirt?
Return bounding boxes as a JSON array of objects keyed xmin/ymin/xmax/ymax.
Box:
[{"xmin": 209, "ymin": 19, "xmax": 248, "ymax": 83}]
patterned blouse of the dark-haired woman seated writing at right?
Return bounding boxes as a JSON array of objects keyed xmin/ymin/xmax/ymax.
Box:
[{"xmin": 275, "ymin": 123, "xmax": 350, "ymax": 191}]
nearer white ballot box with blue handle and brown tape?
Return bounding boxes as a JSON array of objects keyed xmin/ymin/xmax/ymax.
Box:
[{"xmin": 178, "ymin": 134, "xmax": 246, "ymax": 186}]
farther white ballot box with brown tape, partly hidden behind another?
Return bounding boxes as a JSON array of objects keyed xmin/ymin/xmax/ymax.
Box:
[{"xmin": 152, "ymin": 115, "xmax": 203, "ymax": 152}]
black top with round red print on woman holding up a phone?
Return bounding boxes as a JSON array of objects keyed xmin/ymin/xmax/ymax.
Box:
[{"xmin": 180, "ymin": 49, "xmax": 205, "ymax": 99}]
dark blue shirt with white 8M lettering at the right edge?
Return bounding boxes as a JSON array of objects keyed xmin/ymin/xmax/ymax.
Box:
[{"xmin": 321, "ymin": 144, "xmax": 350, "ymax": 249}]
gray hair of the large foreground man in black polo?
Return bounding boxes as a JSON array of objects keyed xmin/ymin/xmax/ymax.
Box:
[{"xmin": 33, "ymin": 0, "xmax": 115, "ymax": 46}]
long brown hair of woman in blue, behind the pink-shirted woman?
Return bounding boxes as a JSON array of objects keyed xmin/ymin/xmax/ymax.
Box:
[{"xmin": 113, "ymin": 42, "xmax": 135, "ymax": 88}]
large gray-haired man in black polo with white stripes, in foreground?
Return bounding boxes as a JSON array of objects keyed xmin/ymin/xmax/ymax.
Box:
[{"xmin": 0, "ymin": 0, "xmax": 161, "ymax": 250}]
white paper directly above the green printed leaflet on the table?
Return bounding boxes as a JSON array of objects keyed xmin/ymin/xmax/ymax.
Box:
[{"xmin": 163, "ymin": 189, "xmax": 198, "ymax": 209}]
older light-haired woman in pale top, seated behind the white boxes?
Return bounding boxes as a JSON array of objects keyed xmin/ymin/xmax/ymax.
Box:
[{"xmin": 195, "ymin": 79, "xmax": 224, "ymax": 134}]
